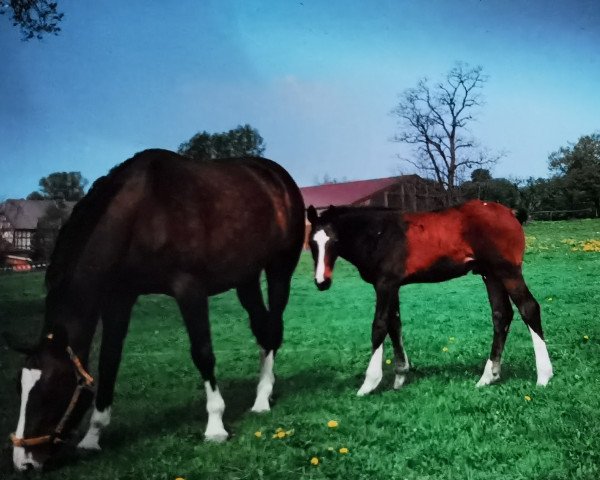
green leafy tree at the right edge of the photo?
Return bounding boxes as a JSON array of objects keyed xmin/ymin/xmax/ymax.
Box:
[{"xmin": 548, "ymin": 133, "xmax": 600, "ymax": 216}]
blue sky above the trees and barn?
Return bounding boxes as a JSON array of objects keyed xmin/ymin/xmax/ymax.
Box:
[{"xmin": 0, "ymin": 0, "xmax": 600, "ymax": 201}]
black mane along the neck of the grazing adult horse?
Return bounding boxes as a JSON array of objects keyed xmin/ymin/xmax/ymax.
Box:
[{"xmin": 46, "ymin": 153, "xmax": 139, "ymax": 291}]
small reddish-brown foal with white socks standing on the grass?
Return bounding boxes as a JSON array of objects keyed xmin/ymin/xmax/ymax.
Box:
[{"xmin": 308, "ymin": 200, "xmax": 552, "ymax": 395}]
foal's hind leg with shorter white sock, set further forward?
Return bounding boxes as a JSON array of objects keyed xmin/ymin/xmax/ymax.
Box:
[{"xmin": 477, "ymin": 275, "xmax": 513, "ymax": 387}]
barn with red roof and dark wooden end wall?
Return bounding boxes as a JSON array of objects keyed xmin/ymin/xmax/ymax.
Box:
[{"xmin": 300, "ymin": 175, "xmax": 445, "ymax": 246}]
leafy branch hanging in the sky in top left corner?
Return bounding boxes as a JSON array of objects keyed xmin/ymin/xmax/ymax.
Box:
[{"xmin": 0, "ymin": 0, "xmax": 64, "ymax": 40}]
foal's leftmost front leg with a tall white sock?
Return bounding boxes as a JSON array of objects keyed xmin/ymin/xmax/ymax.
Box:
[{"xmin": 357, "ymin": 284, "xmax": 398, "ymax": 396}]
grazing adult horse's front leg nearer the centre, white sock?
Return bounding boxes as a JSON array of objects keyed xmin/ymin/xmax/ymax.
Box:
[{"xmin": 173, "ymin": 278, "xmax": 229, "ymax": 442}]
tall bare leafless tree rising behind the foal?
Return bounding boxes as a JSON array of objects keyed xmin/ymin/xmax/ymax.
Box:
[{"xmin": 392, "ymin": 63, "xmax": 502, "ymax": 205}]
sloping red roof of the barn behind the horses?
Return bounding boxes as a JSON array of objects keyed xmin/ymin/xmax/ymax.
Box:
[{"xmin": 300, "ymin": 177, "xmax": 398, "ymax": 208}]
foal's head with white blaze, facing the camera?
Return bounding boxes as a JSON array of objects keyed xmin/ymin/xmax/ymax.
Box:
[{"xmin": 306, "ymin": 205, "xmax": 338, "ymax": 290}]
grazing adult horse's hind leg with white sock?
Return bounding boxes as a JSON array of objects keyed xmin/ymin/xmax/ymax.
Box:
[{"xmin": 237, "ymin": 277, "xmax": 275, "ymax": 412}]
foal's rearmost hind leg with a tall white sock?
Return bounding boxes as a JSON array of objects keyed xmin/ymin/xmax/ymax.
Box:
[{"xmin": 503, "ymin": 272, "xmax": 553, "ymax": 386}]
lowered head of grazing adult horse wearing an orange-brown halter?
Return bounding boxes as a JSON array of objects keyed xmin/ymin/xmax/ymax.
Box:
[{"xmin": 11, "ymin": 329, "xmax": 93, "ymax": 471}]
